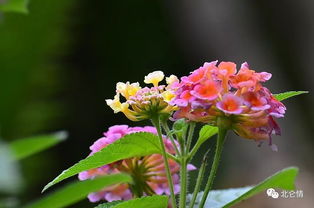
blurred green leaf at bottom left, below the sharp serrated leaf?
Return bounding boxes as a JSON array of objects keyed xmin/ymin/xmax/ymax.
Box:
[{"xmin": 25, "ymin": 174, "xmax": 132, "ymax": 208}]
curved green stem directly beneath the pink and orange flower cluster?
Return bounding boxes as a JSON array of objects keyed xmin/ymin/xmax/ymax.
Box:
[{"xmin": 199, "ymin": 128, "xmax": 227, "ymax": 208}]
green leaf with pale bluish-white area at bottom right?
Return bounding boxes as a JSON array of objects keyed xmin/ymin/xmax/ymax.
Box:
[{"xmin": 189, "ymin": 167, "xmax": 298, "ymax": 208}]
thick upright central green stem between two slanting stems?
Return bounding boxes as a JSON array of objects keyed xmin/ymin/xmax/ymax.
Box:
[{"xmin": 179, "ymin": 122, "xmax": 195, "ymax": 208}]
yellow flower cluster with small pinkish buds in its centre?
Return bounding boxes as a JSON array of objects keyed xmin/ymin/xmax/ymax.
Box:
[{"xmin": 106, "ymin": 71, "xmax": 178, "ymax": 121}]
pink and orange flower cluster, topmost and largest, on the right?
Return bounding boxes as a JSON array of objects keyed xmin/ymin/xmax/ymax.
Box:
[{"xmin": 171, "ymin": 61, "xmax": 286, "ymax": 144}]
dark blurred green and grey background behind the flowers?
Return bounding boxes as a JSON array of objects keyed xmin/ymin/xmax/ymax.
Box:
[{"xmin": 0, "ymin": 0, "xmax": 314, "ymax": 208}]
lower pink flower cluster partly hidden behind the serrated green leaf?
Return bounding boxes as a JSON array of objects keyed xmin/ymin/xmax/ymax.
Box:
[{"xmin": 79, "ymin": 125, "xmax": 195, "ymax": 202}]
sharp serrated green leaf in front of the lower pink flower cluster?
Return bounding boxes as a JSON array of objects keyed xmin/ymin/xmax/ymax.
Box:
[{"xmin": 43, "ymin": 132, "xmax": 160, "ymax": 191}]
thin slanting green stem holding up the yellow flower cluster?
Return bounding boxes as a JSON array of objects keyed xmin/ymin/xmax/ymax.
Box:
[{"xmin": 152, "ymin": 116, "xmax": 177, "ymax": 208}]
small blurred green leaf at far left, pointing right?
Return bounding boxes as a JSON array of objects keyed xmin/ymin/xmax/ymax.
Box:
[{"xmin": 10, "ymin": 131, "xmax": 67, "ymax": 160}]
